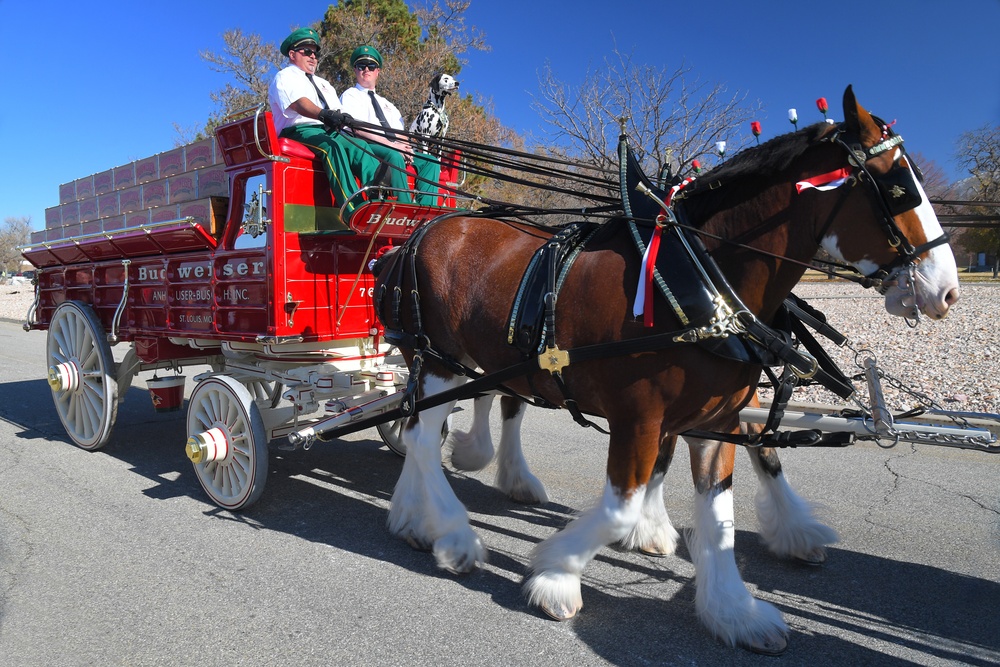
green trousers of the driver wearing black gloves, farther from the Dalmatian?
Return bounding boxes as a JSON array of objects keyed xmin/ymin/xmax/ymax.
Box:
[{"xmin": 281, "ymin": 124, "xmax": 376, "ymax": 215}]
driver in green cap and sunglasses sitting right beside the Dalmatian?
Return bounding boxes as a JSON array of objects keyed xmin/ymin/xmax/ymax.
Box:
[{"xmin": 340, "ymin": 44, "xmax": 441, "ymax": 205}]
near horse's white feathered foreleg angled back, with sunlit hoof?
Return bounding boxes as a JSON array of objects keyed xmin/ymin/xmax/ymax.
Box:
[{"xmin": 524, "ymin": 480, "xmax": 645, "ymax": 621}]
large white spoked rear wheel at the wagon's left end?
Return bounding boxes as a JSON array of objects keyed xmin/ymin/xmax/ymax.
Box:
[{"xmin": 45, "ymin": 301, "xmax": 118, "ymax": 450}]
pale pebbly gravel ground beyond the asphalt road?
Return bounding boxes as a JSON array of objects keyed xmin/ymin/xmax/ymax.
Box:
[{"xmin": 0, "ymin": 281, "xmax": 1000, "ymax": 413}]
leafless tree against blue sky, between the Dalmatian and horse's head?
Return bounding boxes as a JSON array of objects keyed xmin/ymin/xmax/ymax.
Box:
[{"xmin": 533, "ymin": 49, "xmax": 761, "ymax": 189}]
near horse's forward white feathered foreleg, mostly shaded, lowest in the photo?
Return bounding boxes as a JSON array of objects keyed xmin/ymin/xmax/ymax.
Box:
[{"xmin": 685, "ymin": 488, "xmax": 788, "ymax": 653}]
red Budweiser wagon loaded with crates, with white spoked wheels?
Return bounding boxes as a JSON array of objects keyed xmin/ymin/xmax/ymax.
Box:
[{"xmin": 22, "ymin": 108, "xmax": 464, "ymax": 510}]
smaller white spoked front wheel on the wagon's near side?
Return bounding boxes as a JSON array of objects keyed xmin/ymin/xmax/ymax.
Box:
[{"xmin": 187, "ymin": 375, "xmax": 268, "ymax": 510}]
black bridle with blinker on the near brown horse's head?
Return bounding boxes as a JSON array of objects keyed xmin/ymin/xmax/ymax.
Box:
[{"xmin": 821, "ymin": 116, "xmax": 949, "ymax": 294}]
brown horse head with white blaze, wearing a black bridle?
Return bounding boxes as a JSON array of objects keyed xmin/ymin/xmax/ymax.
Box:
[{"xmin": 821, "ymin": 86, "xmax": 959, "ymax": 319}]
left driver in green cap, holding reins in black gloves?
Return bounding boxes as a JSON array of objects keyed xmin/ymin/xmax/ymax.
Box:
[{"xmin": 268, "ymin": 28, "xmax": 378, "ymax": 215}]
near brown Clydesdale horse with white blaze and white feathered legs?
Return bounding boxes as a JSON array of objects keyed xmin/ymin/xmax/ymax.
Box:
[{"xmin": 376, "ymin": 88, "xmax": 958, "ymax": 653}]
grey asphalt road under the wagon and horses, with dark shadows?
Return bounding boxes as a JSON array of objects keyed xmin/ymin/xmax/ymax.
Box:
[{"xmin": 0, "ymin": 322, "xmax": 1000, "ymax": 667}]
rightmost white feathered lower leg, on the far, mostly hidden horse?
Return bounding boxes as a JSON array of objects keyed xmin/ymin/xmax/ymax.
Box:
[{"xmin": 748, "ymin": 450, "xmax": 838, "ymax": 565}]
